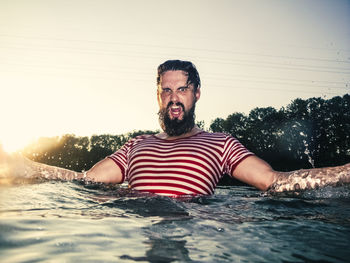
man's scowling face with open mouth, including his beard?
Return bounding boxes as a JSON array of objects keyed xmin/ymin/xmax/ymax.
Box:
[{"xmin": 157, "ymin": 70, "xmax": 200, "ymax": 136}]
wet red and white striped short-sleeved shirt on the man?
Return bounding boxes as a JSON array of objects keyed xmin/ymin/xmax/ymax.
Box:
[{"xmin": 108, "ymin": 132, "xmax": 253, "ymax": 196}]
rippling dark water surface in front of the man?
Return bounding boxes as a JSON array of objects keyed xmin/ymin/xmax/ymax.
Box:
[{"xmin": 0, "ymin": 182, "xmax": 350, "ymax": 262}]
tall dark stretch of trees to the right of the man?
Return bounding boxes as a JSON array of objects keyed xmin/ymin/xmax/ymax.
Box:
[{"xmin": 210, "ymin": 94, "xmax": 350, "ymax": 171}]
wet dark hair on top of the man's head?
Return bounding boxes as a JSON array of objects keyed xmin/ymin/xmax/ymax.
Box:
[{"xmin": 157, "ymin": 60, "xmax": 201, "ymax": 91}]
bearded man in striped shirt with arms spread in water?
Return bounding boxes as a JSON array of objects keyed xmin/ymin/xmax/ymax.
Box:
[{"xmin": 0, "ymin": 60, "xmax": 350, "ymax": 197}]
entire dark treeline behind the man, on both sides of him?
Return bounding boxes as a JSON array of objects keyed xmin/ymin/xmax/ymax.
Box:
[{"xmin": 23, "ymin": 94, "xmax": 350, "ymax": 186}]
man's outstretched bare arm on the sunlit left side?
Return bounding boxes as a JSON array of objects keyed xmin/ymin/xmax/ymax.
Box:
[{"xmin": 0, "ymin": 148, "xmax": 123, "ymax": 186}]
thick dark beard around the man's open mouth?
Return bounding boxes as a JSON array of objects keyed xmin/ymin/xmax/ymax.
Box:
[{"xmin": 158, "ymin": 102, "xmax": 196, "ymax": 136}]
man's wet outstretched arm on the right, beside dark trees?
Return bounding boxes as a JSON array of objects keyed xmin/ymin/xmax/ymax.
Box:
[{"xmin": 232, "ymin": 156, "xmax": 350, "ymax": 192}]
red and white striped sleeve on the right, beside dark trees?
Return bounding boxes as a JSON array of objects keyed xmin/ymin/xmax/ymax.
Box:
[{"xmin": 223, "ymin": 136, "xmax": 254, "ymax": 175}]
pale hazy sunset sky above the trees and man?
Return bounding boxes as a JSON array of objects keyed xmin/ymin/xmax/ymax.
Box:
[{"xmin": 0, "ymin": 0, "xmax": 350, "ymax": 151}]
